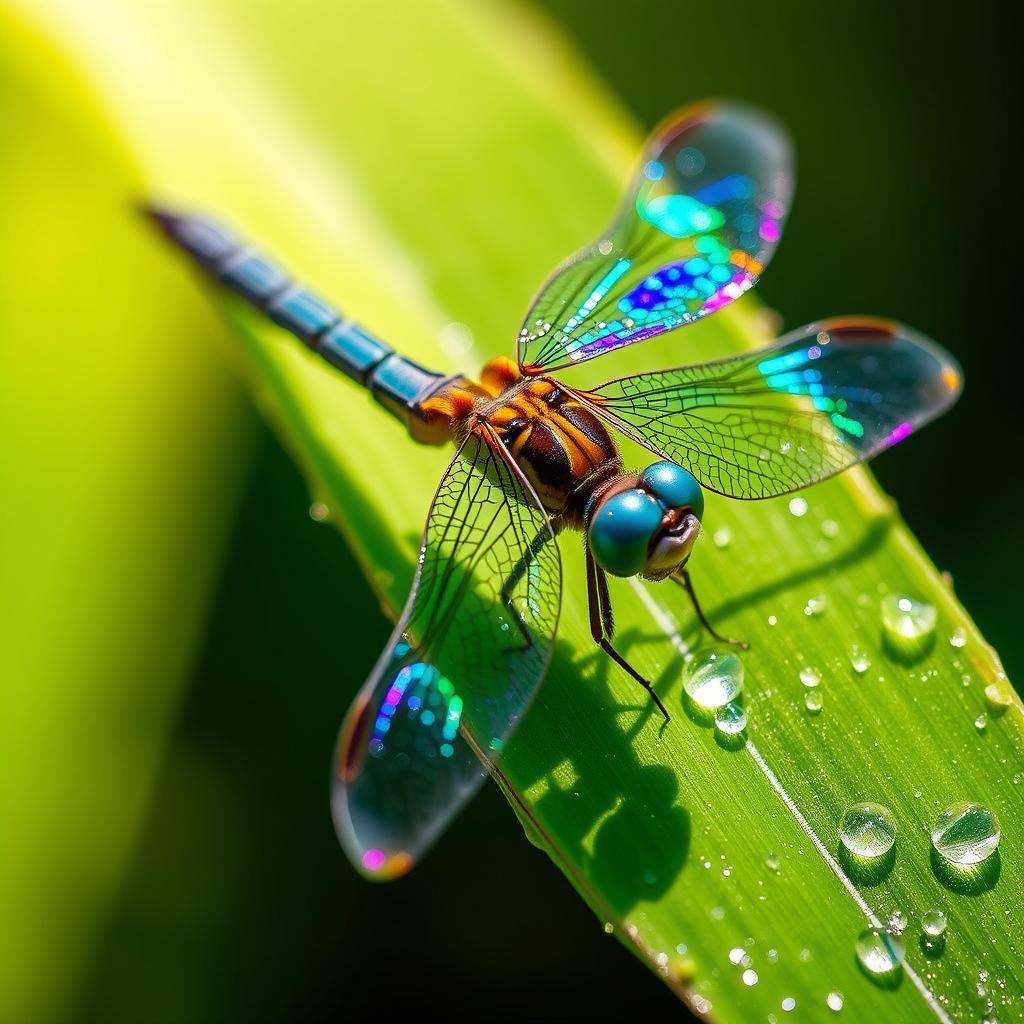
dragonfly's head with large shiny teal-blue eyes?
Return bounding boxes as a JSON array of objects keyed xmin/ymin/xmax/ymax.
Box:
[{"xmin": 587, "ymin": 462, "xmax": 703, "ymax": 580}]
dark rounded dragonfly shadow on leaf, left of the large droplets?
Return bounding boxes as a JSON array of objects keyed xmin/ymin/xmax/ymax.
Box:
[{"xmin": 493, "ymin": 631, "xmax": 691, "ymax": 920}]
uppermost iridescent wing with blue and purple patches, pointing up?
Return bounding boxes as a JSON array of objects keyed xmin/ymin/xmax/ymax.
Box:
[{"xmin": 519, "ymin": 102, "xmax": 793, "ymax": 374}]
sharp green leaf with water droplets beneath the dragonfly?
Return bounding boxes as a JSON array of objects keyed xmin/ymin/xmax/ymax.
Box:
[{"xmin": 9, "ymin": 0, "xmax": 1024, "ymax": 1022}]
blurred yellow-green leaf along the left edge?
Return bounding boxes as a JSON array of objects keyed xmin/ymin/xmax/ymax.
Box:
[{"xmin": 0, "ymin": 4, "xmax": 248, "ymax": 1022}]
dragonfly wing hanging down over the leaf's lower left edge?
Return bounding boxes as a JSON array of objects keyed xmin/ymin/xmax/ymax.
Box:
[{"xmin": 332, "ymin": 428, "xmax": 561, "ymax": 879}]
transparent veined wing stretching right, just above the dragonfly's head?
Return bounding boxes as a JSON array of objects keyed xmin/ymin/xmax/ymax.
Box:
[{"xmin": 580, "ymin": 317, "xmax": 962, "ymax": 498}]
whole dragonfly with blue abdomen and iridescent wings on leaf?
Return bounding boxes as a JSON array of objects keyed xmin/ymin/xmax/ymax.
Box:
[{"xmin": 148, "ymin": 101, "xmax": 962, "ymax": 880}]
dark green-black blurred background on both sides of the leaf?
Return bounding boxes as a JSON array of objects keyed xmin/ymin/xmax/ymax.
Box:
[{"xmin": 79, "ymin": 0, "xmax": 1024, "ymax": 1021}]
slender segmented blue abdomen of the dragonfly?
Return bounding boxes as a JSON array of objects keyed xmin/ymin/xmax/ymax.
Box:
[{"xmin": 147, "ymin": 207, "xmax": 454, "ymax": 444}]
